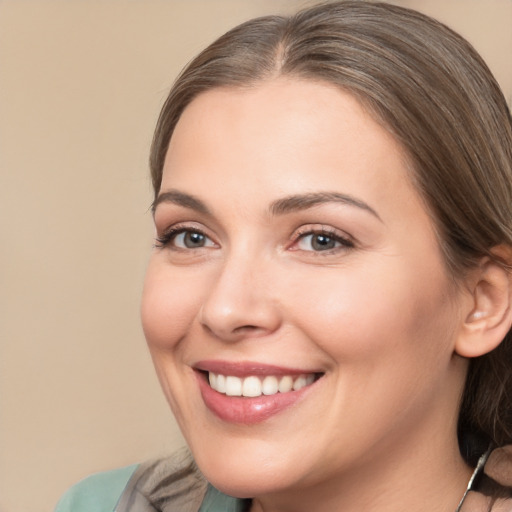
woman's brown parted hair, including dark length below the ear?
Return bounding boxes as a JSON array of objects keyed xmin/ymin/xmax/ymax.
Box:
[{"xmin": 150, "ymin": 0, "xmax": 512, "ymax": 461}]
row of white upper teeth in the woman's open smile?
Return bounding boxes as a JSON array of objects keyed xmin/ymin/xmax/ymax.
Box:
[{"xmin": 208, "ymin": 372, "xmax": 315, "ymax": 397}]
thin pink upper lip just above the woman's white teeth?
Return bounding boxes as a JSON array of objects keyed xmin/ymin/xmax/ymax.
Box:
[{"xmin": 193, "ymin": 360, "xmax": 323, "ymax": 377}]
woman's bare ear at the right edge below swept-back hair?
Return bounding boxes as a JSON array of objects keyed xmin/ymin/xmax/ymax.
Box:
[{"xmin": 455, "ymin": 246, "xmax": 512, "ymax": 357}]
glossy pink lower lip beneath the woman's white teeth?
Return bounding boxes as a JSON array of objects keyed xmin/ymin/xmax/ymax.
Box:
[{"xmin": 197, "ymin": 373, "xmax": 314, "ymax": 425}]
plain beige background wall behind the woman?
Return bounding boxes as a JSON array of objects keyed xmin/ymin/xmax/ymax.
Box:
[{"xmin": 0, "ymin": 0, "xmax": 512, "ymax": 512}]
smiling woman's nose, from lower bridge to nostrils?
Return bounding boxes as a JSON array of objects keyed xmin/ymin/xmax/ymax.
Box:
[{"xmin": 199, "ymin": 254, "xmax": 281, "ymax": 341}]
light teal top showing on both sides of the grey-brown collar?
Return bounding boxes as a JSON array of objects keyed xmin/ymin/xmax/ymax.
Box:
[{"xmin": 55, "ymin": 464, "xmax": 245, "ymax": 512}]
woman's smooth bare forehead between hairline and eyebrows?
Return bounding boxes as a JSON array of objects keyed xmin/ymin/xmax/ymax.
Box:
[{"xmin": 163, "ymin": 78, "xmax": 414, "ymax": 194}]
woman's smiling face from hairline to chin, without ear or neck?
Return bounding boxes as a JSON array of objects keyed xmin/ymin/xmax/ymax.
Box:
[{"xmin": 142, "ymin": 78, "xmax": 465, "ymax": 496}]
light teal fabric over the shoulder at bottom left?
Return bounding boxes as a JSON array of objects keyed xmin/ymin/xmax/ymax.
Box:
[{"xmin": 55, "ymin": 465, "xmax": 138, "ymax": 512}]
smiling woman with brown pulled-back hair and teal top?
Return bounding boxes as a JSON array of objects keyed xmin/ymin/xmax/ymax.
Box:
[{"xmin": 58, "ymin": 1, "xmax": 512, "ymax": 512}]
